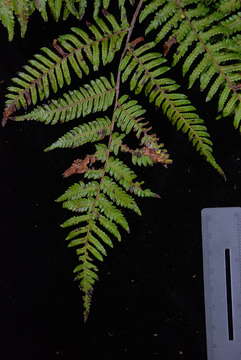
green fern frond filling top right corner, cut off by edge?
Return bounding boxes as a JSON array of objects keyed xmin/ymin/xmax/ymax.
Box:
[{"xmin": 140, "ymin": 0, "xmax": 241, "ymax": 130}]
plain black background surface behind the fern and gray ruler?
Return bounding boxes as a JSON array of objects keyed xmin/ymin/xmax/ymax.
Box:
[{"xmin": 0, "ymin": 8, "xmax": 241, "ymax": 360}]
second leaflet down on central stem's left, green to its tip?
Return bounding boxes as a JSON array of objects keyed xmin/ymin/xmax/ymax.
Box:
[{"xmin": 13, "ymin": 74, "xmax": 115, "ymax": 125}]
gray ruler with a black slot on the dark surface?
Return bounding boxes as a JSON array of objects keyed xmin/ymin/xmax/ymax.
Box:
[{"xmin": 202, "ymin": 207, "xmax": 241, "ymax": 360}]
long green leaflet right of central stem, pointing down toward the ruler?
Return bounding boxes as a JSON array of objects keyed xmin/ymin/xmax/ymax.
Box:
[{"xmin": 121, "ymin": 43, "xmax": 224, "ymax": 176}]
